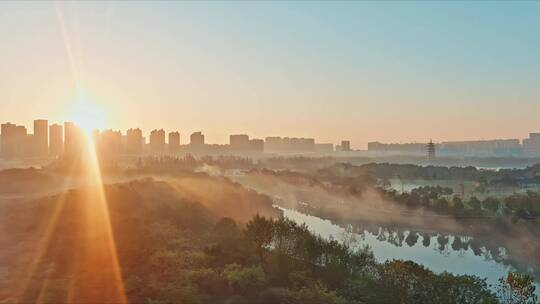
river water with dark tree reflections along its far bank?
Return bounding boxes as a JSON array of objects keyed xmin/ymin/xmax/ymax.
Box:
[{"xmin": 282, "ymin": 209, "xmax": 540, "ymax": 293}]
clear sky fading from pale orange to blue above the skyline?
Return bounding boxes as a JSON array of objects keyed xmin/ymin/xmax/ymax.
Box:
[{"xmin": 0, "ymin": 1, "xmax": 540, "ymax": 148}]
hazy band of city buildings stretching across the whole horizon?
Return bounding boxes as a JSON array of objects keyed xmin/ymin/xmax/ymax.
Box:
[{"xmin": 0, "ymin": 119, "xmax": 540, "ymax": 159}]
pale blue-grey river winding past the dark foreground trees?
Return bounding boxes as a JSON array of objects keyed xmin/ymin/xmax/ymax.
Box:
[{"xmin": 279, "ymin": 207, "xmax": 540, "ymax": 296}]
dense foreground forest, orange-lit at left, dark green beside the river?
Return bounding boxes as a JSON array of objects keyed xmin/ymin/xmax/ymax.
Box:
[{"xmin": 0, "ymin": 167, "xmax": 537, "ymax": 304}]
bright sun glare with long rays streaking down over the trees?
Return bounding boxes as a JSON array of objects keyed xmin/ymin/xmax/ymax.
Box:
[{"xmin": 14, "ymin": 2, "xmax": 127, "ymax": 303}]
